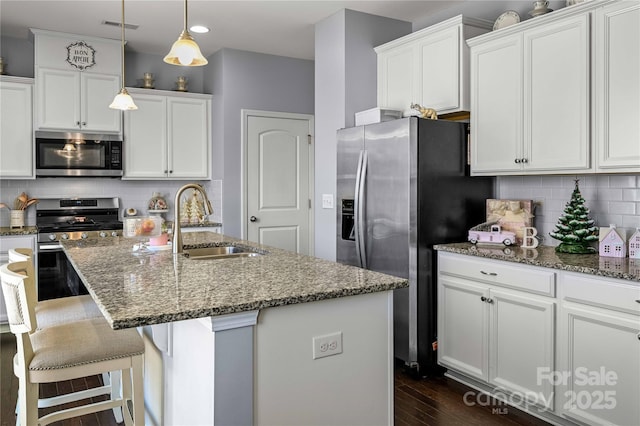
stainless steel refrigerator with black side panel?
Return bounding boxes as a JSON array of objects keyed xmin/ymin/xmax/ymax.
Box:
[{"xmin": 336, "ymin": 117, "xmax": 494, "ymax": 376}]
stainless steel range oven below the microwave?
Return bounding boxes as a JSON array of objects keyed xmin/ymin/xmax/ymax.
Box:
[{"xmin": 36, "ymin": 198, "xmax": 122, "ymax": 300}]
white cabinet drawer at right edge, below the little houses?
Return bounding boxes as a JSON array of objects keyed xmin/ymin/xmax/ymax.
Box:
[{"xmin": 561, "ymin": 272, "xmax": 640, "ymax": 315}]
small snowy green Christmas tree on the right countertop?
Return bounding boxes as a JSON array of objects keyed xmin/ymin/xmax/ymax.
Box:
[{"xmin": 549, "ymin": 179, "xmax": 598, "ymax": 254}]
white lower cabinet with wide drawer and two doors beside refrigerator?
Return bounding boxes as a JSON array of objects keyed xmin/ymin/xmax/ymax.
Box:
[{"xmin": 438, "ymin": 253, "xmax": 556, "ymax": 409}]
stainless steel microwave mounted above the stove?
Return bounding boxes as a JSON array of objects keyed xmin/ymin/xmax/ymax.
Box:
[{"xmin": 35, "ymin": 132, "xmax": 122, "ymax": 177}]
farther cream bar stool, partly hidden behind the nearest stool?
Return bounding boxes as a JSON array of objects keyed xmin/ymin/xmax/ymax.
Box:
[{"xmin": 8, "ymin": 248, "xmax": 123, "ymax": 423}]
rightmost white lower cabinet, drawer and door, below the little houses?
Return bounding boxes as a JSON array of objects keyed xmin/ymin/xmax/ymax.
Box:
[{"xmin": 554, "ymin": 273, "xmax": 640, "ymax": 425}]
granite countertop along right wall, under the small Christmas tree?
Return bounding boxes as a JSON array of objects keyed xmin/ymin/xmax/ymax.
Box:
[{"xmin": 434, "ymin": 243, "xmax": 640, "ymax": 282}]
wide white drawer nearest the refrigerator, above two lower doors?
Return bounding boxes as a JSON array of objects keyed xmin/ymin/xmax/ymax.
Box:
[{"xmin": 438, "ymin": 253, "xmax": 556, "ymax": 297}]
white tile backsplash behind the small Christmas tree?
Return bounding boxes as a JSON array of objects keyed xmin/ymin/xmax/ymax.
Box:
[{"xmin": 497, "ymin": 175, "xmax": 640, "ymax": 246}]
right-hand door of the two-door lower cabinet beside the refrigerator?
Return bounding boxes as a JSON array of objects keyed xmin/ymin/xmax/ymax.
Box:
[{"xmin": 488, "ymin": 289, "xmax": 555, "ymax": 409}]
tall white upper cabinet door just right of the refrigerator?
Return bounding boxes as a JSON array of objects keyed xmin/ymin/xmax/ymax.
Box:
[{"xmin": 471, "ymin": 35, "xmax": 523, "ymax": 174}]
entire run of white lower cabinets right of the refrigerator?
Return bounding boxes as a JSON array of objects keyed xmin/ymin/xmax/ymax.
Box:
[{"xmin": 438, "ymin": 252, "xmax": 640, "ymax": 426}]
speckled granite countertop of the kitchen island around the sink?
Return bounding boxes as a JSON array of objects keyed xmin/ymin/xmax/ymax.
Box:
[{"xmin": 62, "ymin": 232, "xmax": 408, "ymax": 329}]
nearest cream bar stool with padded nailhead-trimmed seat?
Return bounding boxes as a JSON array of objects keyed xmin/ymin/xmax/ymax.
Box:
[{"xmin": 0, "ymin": 262, "xmax": 144, "ymax": 426}]
